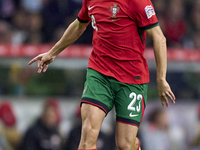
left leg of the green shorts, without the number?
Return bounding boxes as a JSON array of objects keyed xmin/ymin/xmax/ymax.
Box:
[{"xmin": 81, "ymin": 69, "xmax": 114, "ymax": 114}]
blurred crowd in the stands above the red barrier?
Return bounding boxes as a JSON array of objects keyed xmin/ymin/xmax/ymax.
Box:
[{"xmin": 0, "ymin": 0, "xmax": 200, "ymax": 49}]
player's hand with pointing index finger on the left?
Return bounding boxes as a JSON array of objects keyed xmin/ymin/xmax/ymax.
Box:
[{"xmin": 28, "ymin": 52, "xmax": 55, "ymax": 73}]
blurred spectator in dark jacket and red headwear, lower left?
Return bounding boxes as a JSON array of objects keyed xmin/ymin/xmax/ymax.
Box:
[{"xmin": 19, "ymin": 99, "xmax": 62, "ymax": 150}]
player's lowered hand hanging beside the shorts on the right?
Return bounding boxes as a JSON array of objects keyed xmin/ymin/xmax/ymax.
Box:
[{"xmin": 157, "ymin": 80, "xmax": 175, "ymax": 107}]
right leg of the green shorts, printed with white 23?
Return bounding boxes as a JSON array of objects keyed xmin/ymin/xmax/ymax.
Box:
[{"xmin": 115, "ymin": 83, "xmax": 148, "ymax": 127}]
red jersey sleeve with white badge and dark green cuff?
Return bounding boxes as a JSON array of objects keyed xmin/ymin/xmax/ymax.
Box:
[{"xmin": 130, "ymin": 0, "xmax": 159, "ymax": 30}]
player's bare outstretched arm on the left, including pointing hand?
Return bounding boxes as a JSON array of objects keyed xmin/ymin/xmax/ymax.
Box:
[{"xmin": 29, "ymin": 19, "xmax": 89, "ymax": 73}]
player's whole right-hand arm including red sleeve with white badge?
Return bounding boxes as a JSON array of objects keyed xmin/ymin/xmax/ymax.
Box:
[{"xmin": 130, "ymin": 0, "xmax": 175, "ymax": 107}]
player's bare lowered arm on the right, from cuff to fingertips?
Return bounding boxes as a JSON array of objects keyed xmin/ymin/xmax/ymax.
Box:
[{"xmin": 145, "ymin": 26, "xmax": 175, "ymax": 107}]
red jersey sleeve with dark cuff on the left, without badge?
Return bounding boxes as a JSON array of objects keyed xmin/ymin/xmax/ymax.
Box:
[{"xmin": 78, "ymin": 0, "xmax": 90, "ymax": 23}]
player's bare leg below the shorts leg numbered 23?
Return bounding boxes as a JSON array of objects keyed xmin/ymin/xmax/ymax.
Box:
[{"xmin": 115, "ymin": 122, "xmax": 138, "ymax": 149}]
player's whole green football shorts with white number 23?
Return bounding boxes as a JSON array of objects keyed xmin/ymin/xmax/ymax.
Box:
[{"xmin": 81, "ymin": 69, "xmax": 148, "ymax": 127}]
